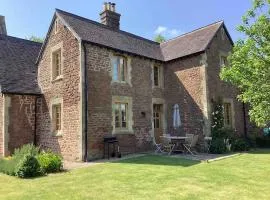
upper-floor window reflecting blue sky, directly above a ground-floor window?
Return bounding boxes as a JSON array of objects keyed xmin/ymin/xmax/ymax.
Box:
[{"xmin": 112, "ymin": 56, "xmax": 127, "ymax": 82}]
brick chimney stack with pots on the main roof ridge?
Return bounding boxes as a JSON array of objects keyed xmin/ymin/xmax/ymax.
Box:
[{"xmin": 100, "ymin": 2, "xmax": 121, "ymax": 30}]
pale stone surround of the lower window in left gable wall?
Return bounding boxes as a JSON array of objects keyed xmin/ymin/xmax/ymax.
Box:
[{"xmin": 50, "ymin": 98, "xmax": 64, "ymax": 136}]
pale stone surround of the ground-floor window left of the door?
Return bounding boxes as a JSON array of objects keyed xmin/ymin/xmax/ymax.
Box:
[{"xmin": 112, "ymin": 96, "xmax": 133, "ymax": 134}]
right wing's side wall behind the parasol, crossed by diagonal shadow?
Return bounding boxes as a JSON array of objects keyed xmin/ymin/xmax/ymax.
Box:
[{"xmin": 165, "ymin": 58, "xmax": 204, "ymax": 137}]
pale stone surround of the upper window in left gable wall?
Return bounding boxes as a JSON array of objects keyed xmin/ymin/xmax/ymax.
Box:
[{"xmin": 51, "ymin": 42, "xmax": 64, "ymax": 82}]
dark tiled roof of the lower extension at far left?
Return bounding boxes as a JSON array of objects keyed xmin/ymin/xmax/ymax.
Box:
[{"xmin": 0, "ymin": 34, "xmax": 41, "ymax": 94}]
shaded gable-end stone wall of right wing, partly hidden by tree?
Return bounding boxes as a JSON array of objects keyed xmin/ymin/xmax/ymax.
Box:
[{"xmin": 207, "ymin": 27, "xmax": 244, "ymax": 134}]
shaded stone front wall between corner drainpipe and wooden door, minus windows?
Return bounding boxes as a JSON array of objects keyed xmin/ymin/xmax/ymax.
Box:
[{"xmin": 86, "ymin": 44, "xmax": 163, "ymax": 159}]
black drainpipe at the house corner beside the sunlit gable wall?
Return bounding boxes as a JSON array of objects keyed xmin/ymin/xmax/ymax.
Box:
[{"xmin": 82, "ymin": 41, "xmax": 88, "ymax": 162}]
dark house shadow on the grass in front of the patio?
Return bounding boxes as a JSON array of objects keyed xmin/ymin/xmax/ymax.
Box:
[{"xmin": 113, "ymin": 155, "xmax": 201, "ymax": 167}]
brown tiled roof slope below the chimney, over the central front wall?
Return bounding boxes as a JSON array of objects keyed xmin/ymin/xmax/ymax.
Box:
[{"xmin": 56, "ymin": 9, "xmax": 163, "ymax": 61}]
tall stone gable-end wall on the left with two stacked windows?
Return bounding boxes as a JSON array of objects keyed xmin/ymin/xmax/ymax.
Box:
[{"xmin": 37, "ymin": 16, "xmax": 82, "ymax": 160}]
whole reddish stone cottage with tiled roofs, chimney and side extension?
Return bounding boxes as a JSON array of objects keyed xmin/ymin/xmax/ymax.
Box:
[{"xmin": 0, "ymin": 3, "xmax": 249, "ymax": 160}]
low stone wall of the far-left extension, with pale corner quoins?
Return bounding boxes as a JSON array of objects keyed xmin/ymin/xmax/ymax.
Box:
[{"xmin": 0, "ymin": 94, "xmax": 36, "ymax": 156}]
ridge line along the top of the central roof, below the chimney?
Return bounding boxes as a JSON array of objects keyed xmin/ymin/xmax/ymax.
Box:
[{"xmin": 55, "ymin": 8, "xmax": 159, "ymax": 45}]
